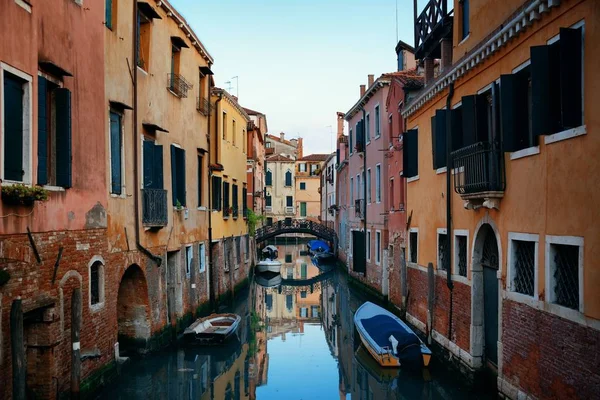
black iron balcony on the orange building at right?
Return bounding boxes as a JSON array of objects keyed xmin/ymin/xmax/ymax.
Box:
[{"xmin": 452, "ymin": 142, "xmax": 506, "ymax": 209}]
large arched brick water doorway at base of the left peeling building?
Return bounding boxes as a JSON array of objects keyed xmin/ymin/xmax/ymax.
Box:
[{"xmin": 117, "ymin": 265, "xmax": 151, "ymax": 353}]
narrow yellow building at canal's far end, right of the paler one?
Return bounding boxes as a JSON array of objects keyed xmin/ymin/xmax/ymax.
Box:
[{"xmin": 295, "ymin": 154, "xmax": 329, "ymax": 221}]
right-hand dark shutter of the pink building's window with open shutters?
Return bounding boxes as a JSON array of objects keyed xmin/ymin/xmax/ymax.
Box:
[{"xmin": 54, "ymin": 88, "xmax": 72, "ymax": 188}]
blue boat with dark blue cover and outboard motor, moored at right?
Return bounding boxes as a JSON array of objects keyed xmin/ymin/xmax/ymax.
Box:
[{"xmin": 354, "ymin": 301, "xmax": 431, "ymax": 368}]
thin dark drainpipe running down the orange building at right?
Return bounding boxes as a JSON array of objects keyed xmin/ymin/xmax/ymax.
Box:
[{"xmin": 446, "ymin": 82, "xmax": 454, "ymax": 339}]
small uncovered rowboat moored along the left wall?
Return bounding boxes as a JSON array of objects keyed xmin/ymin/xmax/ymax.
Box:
[{"xmin": 183, "ymin": 314, "xmax": 242, "ymax": 344}]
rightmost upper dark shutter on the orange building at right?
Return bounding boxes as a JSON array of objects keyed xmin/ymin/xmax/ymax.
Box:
[{"xmin": 559, "ymin": 28, "xmax": 583, "ymax": 129}]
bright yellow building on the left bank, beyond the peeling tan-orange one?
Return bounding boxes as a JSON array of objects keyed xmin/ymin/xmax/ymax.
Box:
[{"xmin": 210, "ymin": 88, "xmax": 252, "ymax": 293}]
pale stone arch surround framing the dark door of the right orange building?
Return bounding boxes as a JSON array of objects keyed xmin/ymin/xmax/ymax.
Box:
[{"xmin": 471, "ymin": 213, "xmax": 503, "ymax": 371}]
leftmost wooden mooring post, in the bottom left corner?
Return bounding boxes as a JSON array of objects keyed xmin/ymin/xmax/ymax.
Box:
[{"xmin": 10, "ymin": 299, "xmax": 27, "ymax": 400}]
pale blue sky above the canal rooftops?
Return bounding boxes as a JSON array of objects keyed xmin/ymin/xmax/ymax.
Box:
[{"xmin": 170, "ymin": 0, "xmax": 426, "ymax": 155}]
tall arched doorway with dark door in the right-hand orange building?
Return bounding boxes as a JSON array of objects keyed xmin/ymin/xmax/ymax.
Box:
[{"xmin": 471, "ymin": 223, "xmax": 500, "ymax": 370}]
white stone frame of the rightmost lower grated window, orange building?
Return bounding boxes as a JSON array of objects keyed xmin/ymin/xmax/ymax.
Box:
[{"xmin": 544, "ymin": 235, "xmax": 584, "ymax": 320}]
